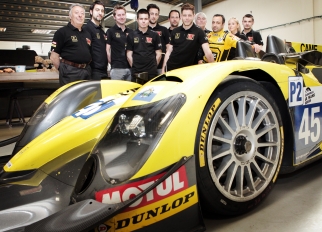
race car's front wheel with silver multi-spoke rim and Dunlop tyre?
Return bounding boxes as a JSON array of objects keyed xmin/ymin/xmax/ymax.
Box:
[{"xmin": 195, "ymin": 76, "xmax": 284, "ymax": 216}]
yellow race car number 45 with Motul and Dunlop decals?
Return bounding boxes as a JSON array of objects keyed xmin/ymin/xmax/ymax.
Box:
[{"xmin": 0, "ymin": 36, "xmax": 322, "ymax": 232}]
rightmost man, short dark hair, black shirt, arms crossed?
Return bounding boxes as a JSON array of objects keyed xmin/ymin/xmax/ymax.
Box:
[{"xmin": 242, "ymin": 14, "xmax": 264, "ymax": 53}]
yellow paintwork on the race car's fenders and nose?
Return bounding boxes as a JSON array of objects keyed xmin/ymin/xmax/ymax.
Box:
[{"xmin": 4, "ymin": 60, "xmax": 321, "ymax": 182}]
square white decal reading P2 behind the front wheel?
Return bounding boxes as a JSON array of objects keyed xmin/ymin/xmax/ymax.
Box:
[{"xmin": 288, "ymin": 76, "xmax": 304, "ymax": 107}]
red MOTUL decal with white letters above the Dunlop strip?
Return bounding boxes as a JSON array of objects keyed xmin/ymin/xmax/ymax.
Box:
[{"xmin": 95, "ymin": 166, "xmax": 188, "ymax": 211}]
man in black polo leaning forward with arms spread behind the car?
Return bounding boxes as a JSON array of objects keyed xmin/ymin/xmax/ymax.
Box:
[{"xmin": 162, "ymin": 3, "xmax": 214, "ymax": 73}]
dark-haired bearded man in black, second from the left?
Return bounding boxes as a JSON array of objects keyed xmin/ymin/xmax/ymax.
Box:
[{"xmin": 83, "ymin": 1, "xmax": 107, "ymax": 80}]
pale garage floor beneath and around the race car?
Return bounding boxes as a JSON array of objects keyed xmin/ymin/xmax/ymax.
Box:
[{"xmin": 0, "ymin": 121, "xmax": 322, "ymax": 232}]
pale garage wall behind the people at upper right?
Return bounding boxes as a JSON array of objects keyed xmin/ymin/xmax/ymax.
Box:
[{"xmin": 164, "ymin": 0, "xmax": 322, "ymax": 47}]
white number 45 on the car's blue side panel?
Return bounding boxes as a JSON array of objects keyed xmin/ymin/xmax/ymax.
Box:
[{"xmin": 299, "ymin": 106, "xmax": 321, "ymax": 145}]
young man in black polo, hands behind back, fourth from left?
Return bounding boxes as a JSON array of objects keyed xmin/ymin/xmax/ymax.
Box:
[{"xmin": 126, "ymin": 9, "xmax": 162, "ymax": 80}]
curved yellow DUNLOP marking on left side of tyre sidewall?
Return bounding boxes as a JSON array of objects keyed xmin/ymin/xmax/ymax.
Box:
[{"xmin": 199, "ymin": 98, "xmax": 221, "ymax": 167}]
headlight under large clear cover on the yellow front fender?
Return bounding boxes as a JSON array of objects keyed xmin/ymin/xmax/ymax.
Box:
[{"xmin": 95, "ymin": 94, "xmax": 186, "ymax": 184}]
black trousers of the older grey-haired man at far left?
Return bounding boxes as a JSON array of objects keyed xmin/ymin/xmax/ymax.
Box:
[{"xmin": 59, "ymin": 62, "xmax": 92, "ymax": 86}]
